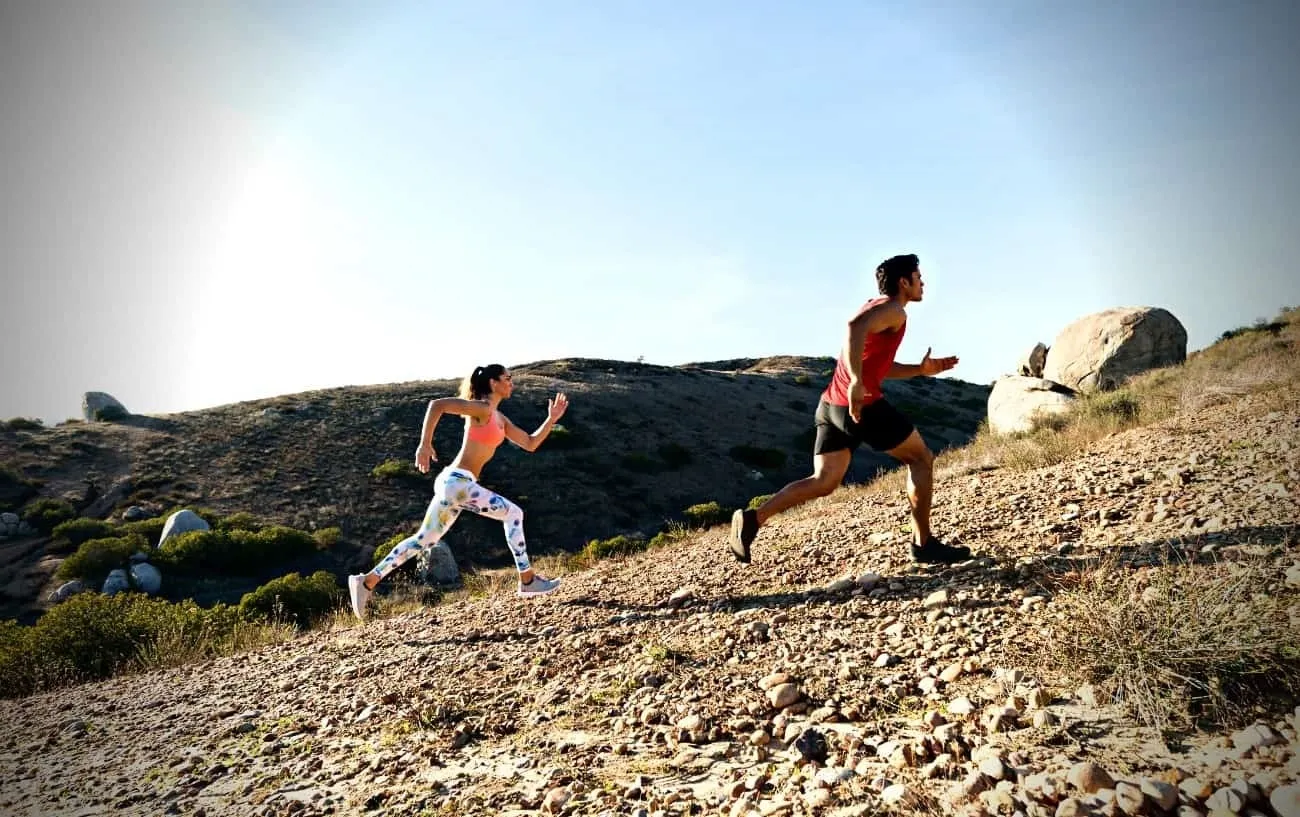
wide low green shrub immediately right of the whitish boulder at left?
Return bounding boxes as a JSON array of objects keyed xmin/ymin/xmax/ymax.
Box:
[{"xmin": 155, "ymin": 526, "xmax": 317, "ymax": 575}]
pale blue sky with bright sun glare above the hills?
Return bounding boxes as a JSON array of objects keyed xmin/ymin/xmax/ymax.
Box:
[{"xmin": 0, "ymin": 0, "xmax": 1300, "ymax": 423}]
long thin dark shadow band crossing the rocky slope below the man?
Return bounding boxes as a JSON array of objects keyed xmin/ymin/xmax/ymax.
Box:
[{"xmin": 407, "ymin": 524, "xmax": 1300, "ymax": 647}]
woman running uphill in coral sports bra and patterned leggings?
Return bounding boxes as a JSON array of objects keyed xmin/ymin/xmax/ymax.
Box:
[{"xmin": 347, "ymin": 363, "xmax": 568, "ymax": 619}]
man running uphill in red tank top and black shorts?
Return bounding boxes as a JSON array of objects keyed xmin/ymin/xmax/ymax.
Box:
[{"xmin": 731, "ymin": 255, "xmax": 970, "ymax": 563}]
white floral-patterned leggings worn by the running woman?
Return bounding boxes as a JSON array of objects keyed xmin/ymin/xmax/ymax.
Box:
[{"xmin": 371, "ymin": 468, "xmax": 529, "ymax": 579}]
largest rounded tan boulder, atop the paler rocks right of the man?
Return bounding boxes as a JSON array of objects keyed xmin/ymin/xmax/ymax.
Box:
[{"xmin": 1043, "ymin": 307, "xmax": 1187, "ymax": 392}]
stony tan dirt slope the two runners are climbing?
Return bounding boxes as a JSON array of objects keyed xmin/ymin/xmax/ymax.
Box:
[{"xmin": 0, "ymin": 385, "xmax": 1300, "ymax": 816}]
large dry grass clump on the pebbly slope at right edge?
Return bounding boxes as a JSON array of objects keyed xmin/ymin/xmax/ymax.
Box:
[{"xmin": 1044, "ymin": 557, "xmax": 1300, "ymax": 731}]
